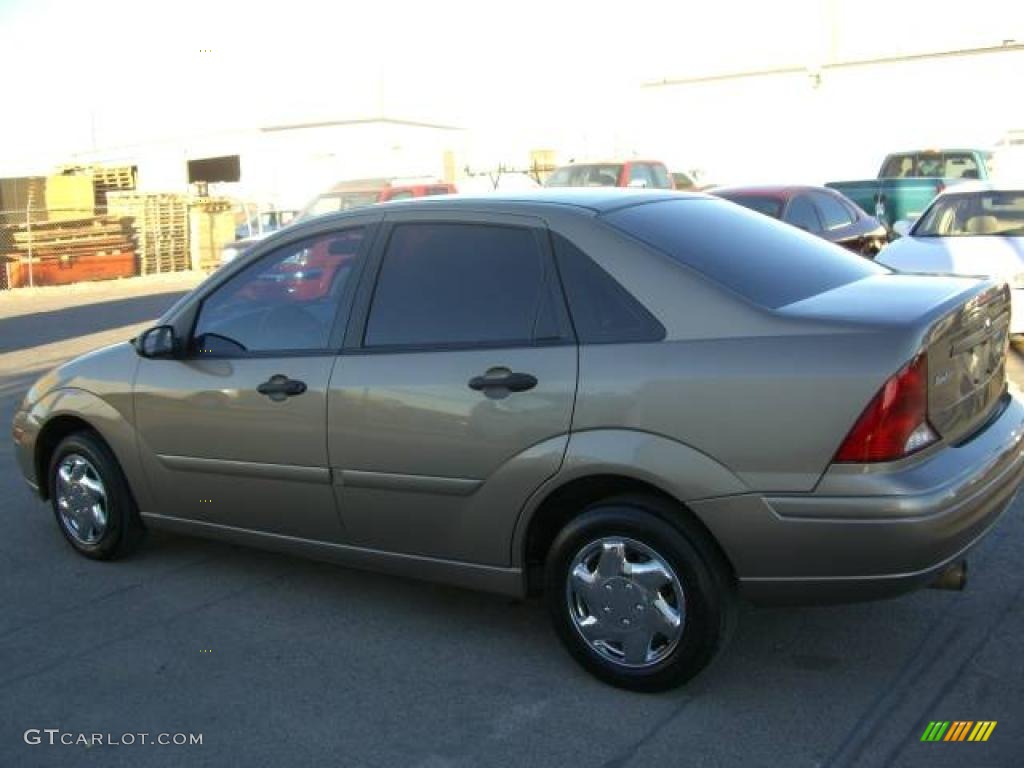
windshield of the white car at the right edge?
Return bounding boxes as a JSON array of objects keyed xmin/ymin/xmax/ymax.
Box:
[{"xmin": 912, "ymin": 189, "xmax": 1024, "ymax": 238}]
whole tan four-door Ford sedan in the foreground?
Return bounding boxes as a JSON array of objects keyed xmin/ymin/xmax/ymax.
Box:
[{"xmin": 12, "ymin": 189, "xmax": 1024, "ymax": 690}]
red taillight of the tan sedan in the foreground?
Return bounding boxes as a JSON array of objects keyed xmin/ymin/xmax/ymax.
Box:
[{"xmin": 836, "ymin": 352, "xmax": 939, "ymax": 463}]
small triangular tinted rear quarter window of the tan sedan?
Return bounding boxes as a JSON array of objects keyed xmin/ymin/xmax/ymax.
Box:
[{"xmin": 552, "ymin": 234, "xmax": 665, "ymax": 344}]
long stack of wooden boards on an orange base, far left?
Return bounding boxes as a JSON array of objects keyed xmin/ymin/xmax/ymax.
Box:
[{"xmin": 0, "ymin": 216, "xmax": 136, "ymax": 288}]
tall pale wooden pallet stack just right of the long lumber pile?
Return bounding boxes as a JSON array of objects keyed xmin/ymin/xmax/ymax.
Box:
[{"xmin": 106, "ymin": 191, "xmax": 191, "ymax": 274}]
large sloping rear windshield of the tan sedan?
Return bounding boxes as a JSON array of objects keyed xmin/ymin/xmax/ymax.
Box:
[{"xmin": 603, "ymin": 200, "xmax": 889, "ymax": 309}]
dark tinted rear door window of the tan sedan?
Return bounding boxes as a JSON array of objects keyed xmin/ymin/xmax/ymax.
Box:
[{"xmin": 366, "ymin": 224, "xmax": 551, "ymax": 346}]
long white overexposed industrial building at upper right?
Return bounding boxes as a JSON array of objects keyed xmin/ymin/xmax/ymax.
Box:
[{"xmin": 629, "ymin": 42, "xmax": 1024, "ymax": 183}]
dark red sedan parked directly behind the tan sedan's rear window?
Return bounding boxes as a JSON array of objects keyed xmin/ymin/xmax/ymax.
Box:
[{"xmin": 709, "ymin": 186, "xmax": 887, "ymax": 258}]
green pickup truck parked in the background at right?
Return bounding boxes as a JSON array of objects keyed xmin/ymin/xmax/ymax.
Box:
[{"xmin": 825, "ymin": 150, "xmax": 992, "ymax": 232}]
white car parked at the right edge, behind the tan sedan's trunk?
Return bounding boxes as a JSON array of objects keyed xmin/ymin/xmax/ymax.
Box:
[{"xmin": 876, "ymin": 182, "xmax": 1024, "ymax": 336}]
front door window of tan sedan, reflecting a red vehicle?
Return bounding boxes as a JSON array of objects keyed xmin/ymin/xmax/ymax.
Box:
[{"xmin": 194, "ymin": 228, "xmax": 364, "ymax": 354}]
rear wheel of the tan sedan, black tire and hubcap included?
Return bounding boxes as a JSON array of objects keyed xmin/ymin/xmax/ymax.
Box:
[{"xmin": 545, "ymin": 496, "xmax": 736, "ymax": 691}]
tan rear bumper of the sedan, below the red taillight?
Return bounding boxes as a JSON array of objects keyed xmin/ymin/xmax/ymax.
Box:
[{"xmin": 693, "ymin": 396, "xmax": 1024, "ymax": 602}]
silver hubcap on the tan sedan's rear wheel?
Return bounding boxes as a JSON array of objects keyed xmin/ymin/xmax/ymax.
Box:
[{"xmin": 565, "ymin": 537, "xmax": 686, "ymax": 668}]
